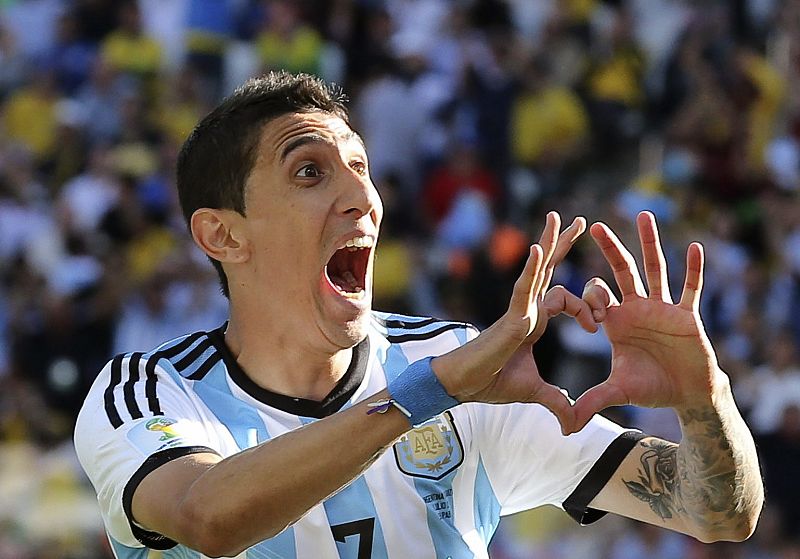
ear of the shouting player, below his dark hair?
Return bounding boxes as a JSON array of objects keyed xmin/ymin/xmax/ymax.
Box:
[{"xmin": 189, "ymin": 208, "xmax": 250, "ymax": 264}]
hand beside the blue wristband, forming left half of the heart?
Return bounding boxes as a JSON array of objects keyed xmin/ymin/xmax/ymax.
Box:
[{"xmin": 432, "ymin": 212, "xmax": 597, "ymax": 432}]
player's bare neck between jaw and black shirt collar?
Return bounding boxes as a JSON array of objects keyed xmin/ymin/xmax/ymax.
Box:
[{"xmin": 225, "ymin": 305, "xmax": 353, "ymax": 401}]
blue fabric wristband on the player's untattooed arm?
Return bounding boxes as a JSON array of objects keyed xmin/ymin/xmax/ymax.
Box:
[{"xmin": 389, "ymin": 357, "xmax": 459, "ymax": 427}]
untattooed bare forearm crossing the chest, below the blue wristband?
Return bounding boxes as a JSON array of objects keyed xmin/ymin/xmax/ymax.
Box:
[{"xmin": 167, "ymin": 391, "xmax": 409, "ymax": 555}]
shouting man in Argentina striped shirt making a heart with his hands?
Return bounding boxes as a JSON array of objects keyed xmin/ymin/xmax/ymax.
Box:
[{"xmin": 75, "ymin": 73, "xmax": 763, "ymax": 559}]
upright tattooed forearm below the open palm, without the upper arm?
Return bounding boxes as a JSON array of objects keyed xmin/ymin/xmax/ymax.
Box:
[{"xmin": 675, "ymin": 372, "xmax": 764, "ymax": 540}]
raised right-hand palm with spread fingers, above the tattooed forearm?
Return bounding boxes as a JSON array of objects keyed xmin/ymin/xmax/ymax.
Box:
[{"xmin": 574, "ymin": 212, "xmax": 724, "ymax": 430}]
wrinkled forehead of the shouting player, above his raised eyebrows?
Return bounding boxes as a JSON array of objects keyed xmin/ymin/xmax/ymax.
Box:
[{"xmin": 259, "ymin": 111, "xmax": 363, "ymax": 164}]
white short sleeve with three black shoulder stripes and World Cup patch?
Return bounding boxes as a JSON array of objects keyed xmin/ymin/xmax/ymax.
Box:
[{"xmin": 75, "ymin": 354, "xmax": 221, "ymax": 549}]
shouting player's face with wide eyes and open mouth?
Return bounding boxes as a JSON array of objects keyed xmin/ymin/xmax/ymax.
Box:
[{"xmin": 232, "ymin": 112, "xmax": 383, "ymax": 349}]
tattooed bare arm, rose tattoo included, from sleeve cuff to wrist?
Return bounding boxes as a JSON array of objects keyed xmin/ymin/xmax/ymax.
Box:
[{"xmin": 620, "ymin": 373, "xmax": 764, "ymax": 541}]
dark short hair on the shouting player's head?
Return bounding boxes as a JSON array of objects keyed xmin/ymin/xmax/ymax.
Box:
[{"xmin": 177, "ymin": 71, "xmax": 349, "ymax": 297}]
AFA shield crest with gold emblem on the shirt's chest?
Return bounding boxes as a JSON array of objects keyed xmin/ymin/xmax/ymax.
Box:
[{"xmin": 392, "ymin": 412, "xmax": 464, "ymax": 479}]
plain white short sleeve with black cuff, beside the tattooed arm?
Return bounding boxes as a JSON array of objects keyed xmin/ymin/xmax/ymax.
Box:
[{"xmin": 467, "ymin": 404, "xmax": 642, "ymax": 524}]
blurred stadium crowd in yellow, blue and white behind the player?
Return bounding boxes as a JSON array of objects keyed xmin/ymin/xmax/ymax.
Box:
[{"xmin": 0, "ymin": 0, "xmax": 800, "ymax": 559}]
